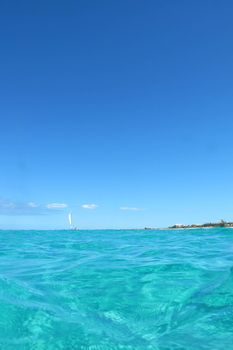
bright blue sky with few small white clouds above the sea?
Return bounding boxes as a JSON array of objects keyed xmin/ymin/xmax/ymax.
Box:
[{"xmin": 0, "ymin": 0, "xmax": 233, "ymax": 228}]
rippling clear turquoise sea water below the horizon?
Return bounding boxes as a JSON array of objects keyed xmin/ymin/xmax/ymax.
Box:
[{"xmin": 0, "ymin": 229, "xmax": 233, "ymax": 350}]
